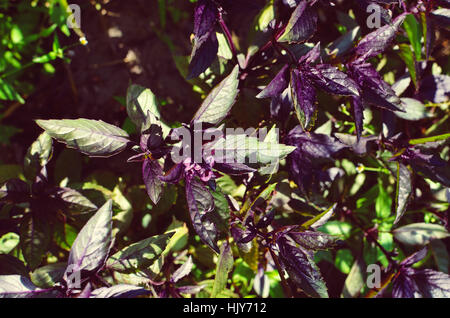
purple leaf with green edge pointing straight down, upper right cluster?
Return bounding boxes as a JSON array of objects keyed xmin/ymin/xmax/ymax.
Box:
[{"xmin": 291, "ymin": 69, "xmax": 317, "ymax": 129}]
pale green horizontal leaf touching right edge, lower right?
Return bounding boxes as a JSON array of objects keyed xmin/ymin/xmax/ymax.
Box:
[{"xmin": 393, "ymin": 223, "xmax": 450, "ymax": 246}]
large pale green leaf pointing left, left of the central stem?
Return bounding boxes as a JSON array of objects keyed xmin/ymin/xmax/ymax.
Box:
[{"xmin": 36, "ymin": 118, "xmax": 129, "ymax": 157}]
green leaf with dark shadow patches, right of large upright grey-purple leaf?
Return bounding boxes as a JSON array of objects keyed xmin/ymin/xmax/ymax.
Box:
[{"xmin": 106, "ymin": 232, "xmax": 174, "ymax": 272}]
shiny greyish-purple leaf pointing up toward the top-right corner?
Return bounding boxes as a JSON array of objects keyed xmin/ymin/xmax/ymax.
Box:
[{"xmin": 355, "ymin": 14, "xmax": 406, "ymax": 59}]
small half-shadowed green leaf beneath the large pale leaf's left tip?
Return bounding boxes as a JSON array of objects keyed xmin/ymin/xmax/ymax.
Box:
[{"xmin": 23, "ymin": 131, "xmax": 53, "ymax": 181}]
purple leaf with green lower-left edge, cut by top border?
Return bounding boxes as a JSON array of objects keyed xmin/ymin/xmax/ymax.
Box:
[{"xmin": 278, "ymin": 1, "xmax": 317, "ymax": 42}]
